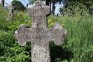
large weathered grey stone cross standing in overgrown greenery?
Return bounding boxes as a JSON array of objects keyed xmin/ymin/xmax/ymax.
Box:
[{"xmin": 15, "ymin": 0, "xmax": 66, "ymax": 62}]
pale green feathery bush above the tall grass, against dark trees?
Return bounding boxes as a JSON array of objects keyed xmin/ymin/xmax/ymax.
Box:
[{"xmin": 61, "ymin": 3, "xmax": 88, "ymax": 16}]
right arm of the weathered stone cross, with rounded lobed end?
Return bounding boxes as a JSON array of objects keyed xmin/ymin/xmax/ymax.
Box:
[{"xmin": 48, "ymin": 23, "xmax": 67, "ymax": 45}]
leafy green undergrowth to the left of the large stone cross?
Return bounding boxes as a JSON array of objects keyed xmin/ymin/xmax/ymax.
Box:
[{"xmin": 0, "ymin": 6, "xmax": 30, "ymax": 62}]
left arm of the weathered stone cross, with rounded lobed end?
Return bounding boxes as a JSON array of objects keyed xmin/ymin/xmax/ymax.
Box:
[{"xmin": 14, "ymin": 24, "xmax": 30, "ymax": 46}]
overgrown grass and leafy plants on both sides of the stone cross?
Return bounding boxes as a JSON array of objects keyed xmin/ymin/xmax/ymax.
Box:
[{"xmin": 0, "ymin": 3, "xmax": 93, "ymax": 62}]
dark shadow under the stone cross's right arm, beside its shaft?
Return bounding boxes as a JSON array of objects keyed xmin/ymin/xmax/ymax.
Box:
[{"xmin": 50, "ymin": 44, "xmax": 73, "ymax": 62}]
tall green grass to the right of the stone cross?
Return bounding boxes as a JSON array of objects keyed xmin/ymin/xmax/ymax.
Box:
[{"xmin": 49, "ymin": 12, "xmax": 93, "ymax": 62}]
